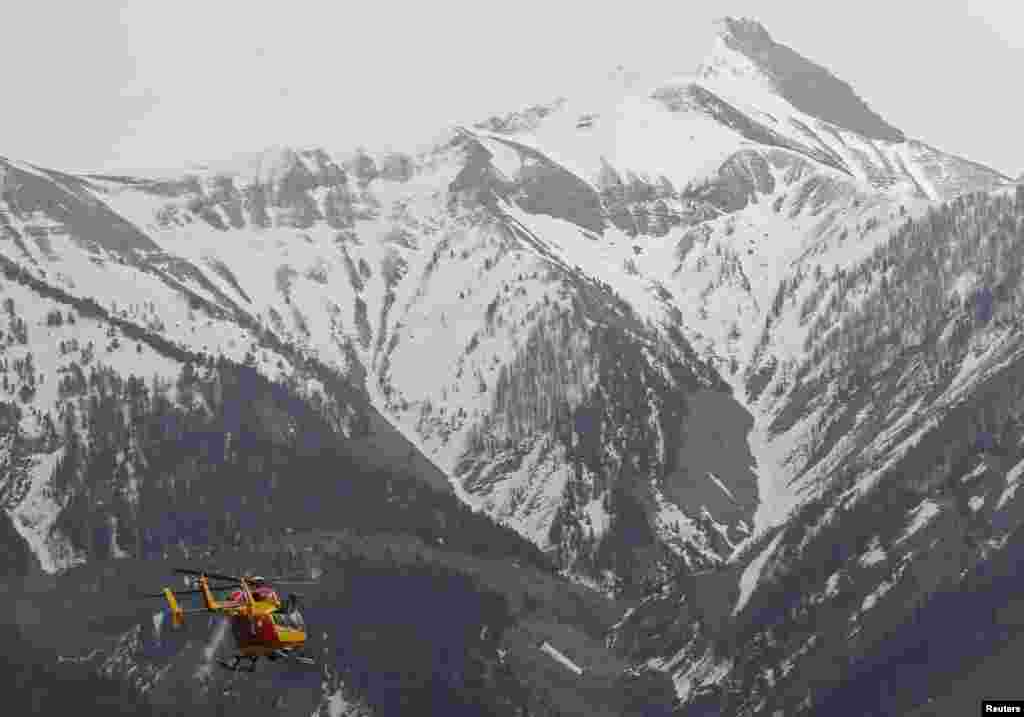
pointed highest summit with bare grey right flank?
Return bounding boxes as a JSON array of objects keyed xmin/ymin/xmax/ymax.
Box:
[{"xmin": 697, "ymin": 17, "xmax": 905, "ymax": 142}]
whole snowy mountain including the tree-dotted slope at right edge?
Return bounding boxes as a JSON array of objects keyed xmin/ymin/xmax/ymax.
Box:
[{"xmin": 0, "ymin": 18, "xmax": 1021, "ymax": 714}]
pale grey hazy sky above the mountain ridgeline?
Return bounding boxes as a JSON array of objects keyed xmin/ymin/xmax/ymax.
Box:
[{"xmin": 0, "ymin": 0, "xmax": 1024, "ymax": 176}]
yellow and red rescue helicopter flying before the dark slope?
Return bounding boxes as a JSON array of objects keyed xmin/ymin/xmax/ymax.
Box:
[{"xmin": 143, "ymin": 568, "xmax": 315, "ymax": 672}]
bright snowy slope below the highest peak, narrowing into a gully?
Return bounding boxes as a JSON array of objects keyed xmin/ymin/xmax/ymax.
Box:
[{"xmin": 468, "ymin": 18, "xmax": 1009, "ymax": 544}]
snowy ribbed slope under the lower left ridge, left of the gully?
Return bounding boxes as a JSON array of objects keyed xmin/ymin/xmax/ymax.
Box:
[{"xmin": 0, "ymin": 138, "xmax": 737, "ymax": 598}]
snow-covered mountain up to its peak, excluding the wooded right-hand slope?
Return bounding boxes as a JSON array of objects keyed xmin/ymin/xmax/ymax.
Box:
[{"xmin": 0, "ymin": 19, "xmax": 1009, "ymax": 572}]
